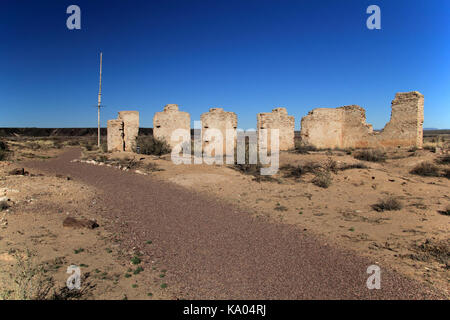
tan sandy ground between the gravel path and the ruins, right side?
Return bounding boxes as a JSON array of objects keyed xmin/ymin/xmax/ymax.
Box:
[{"xmin": 103, "ymin": 150, "xmax": 450, "ymax": 293}]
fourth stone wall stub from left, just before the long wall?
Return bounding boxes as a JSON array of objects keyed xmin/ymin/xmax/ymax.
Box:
[{"xmin": 257, "ymin": 108, "xmax": 295, "ymax": 151}]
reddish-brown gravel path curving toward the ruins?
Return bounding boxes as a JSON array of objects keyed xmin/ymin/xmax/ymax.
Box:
[{"xmin": 27, "ymin": 150, "xmax": 444, "ymax": 299}]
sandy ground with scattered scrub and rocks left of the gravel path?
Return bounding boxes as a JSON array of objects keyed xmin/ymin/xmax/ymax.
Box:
[{"xmin": 0, "ymin": 139, "xmax": 171, "ymax": 300}]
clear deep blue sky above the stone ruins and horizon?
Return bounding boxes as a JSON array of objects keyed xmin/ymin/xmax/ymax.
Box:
[{"xmin": 0, "ymin": 0, "xmax": 450, "ymax": 129}]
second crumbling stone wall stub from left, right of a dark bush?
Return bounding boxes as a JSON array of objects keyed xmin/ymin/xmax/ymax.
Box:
[{"xmin": 153, "ymin": 104, "xmax": 191, "ymax": 148}]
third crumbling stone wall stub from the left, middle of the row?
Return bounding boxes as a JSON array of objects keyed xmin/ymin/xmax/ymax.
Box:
[{"xmin": 200, "ymin": 108, "xmax": 237, "ymax": 156}]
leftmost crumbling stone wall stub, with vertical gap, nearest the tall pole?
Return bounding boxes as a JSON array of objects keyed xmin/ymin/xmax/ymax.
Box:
[{"xmin": 107, "ymin": 111, "xmax": 139, "ymax": 152}]
